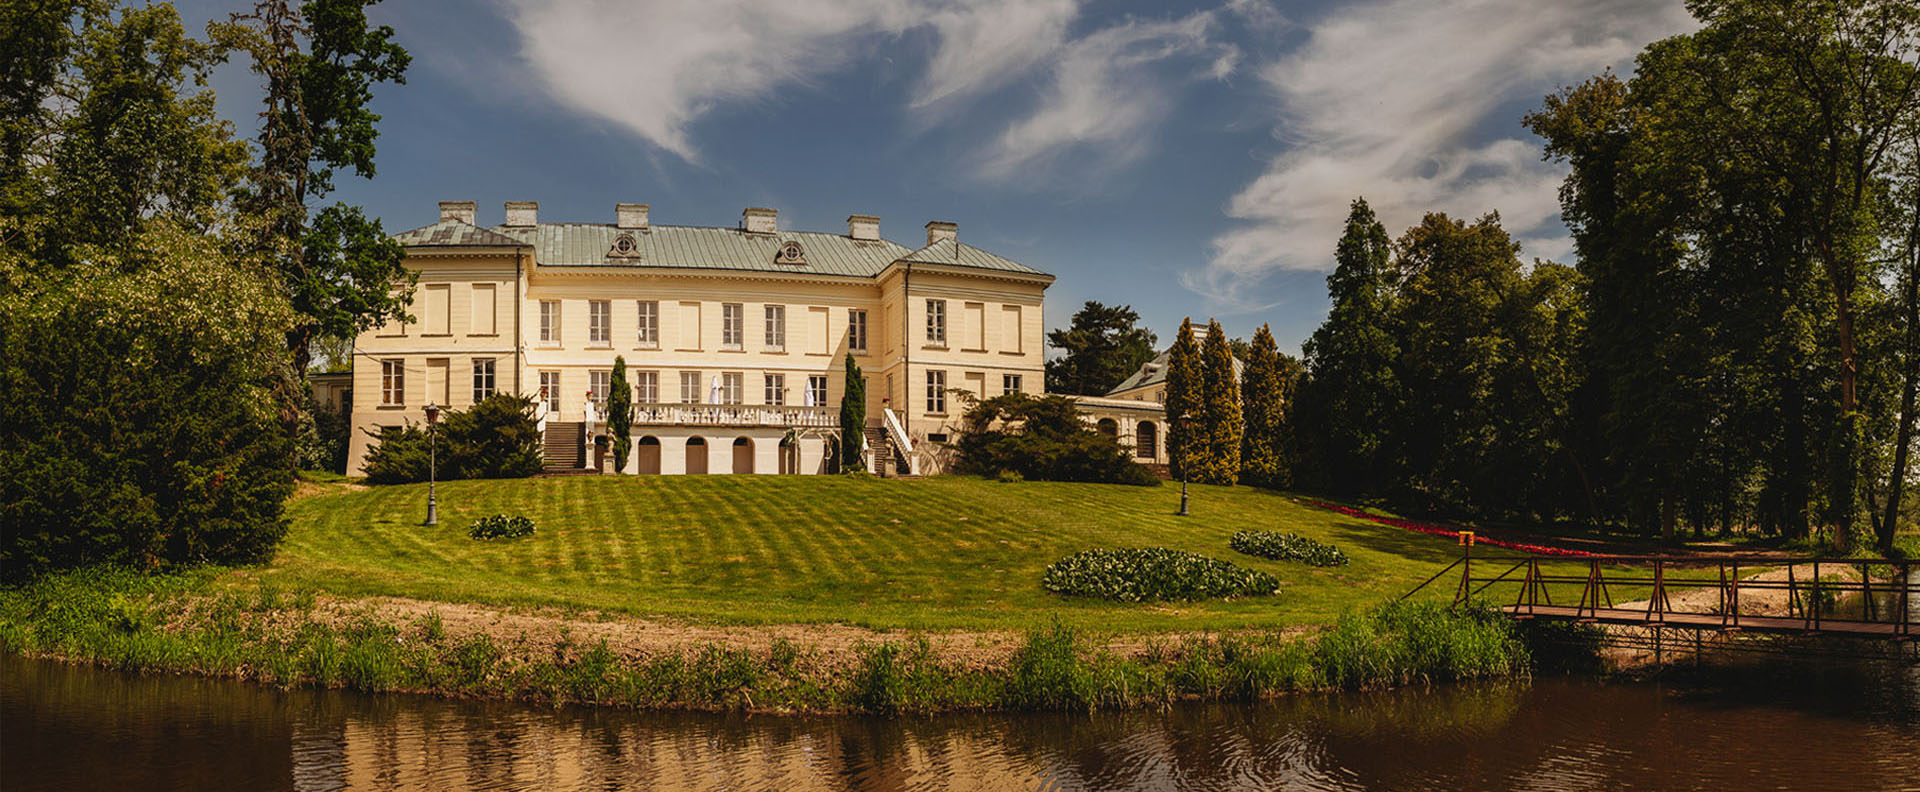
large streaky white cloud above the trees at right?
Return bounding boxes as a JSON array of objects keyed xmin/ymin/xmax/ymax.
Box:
[{"xmin": 1187, "ymin": 0, "xmax": 1693, "ymax": 305}]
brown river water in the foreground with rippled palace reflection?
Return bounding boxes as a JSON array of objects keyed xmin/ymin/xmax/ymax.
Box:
[{"xmin": 0, "ymin": 658, "xmax": 1920, "ymax": 790}]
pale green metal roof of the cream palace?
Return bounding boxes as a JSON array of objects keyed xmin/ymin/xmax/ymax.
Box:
[{"xmin": 394, "ymin": 221, "xmax": 1043, "ymax": 278}]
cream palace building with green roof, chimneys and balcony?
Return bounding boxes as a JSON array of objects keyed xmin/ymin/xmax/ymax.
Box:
[{"xmin": 351, "ymin": 201, "xmax": 1054, "ymax": 474}]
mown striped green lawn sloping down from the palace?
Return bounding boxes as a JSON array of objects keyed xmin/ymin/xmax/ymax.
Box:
[{"xmin": 274, "ymin": 476, "xmax": 1457, "ymax": 631}]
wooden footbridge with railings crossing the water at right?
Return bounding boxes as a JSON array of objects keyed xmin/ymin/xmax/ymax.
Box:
[{"xmin": 1402, "ymin": 537, "xmax": 1920, "ymax": 642}]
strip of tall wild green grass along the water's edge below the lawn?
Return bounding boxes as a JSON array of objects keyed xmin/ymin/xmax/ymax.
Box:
[{"xmin": 0, "ymin": 570, "xmax": 1530, "ymax": 713}]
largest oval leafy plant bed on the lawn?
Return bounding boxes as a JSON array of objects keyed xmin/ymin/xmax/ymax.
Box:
[{"xmin": 1041, "ymin": 547, "xmax": 1281, "ymax": 602}]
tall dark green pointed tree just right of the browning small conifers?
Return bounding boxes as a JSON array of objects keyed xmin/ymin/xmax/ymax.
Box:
[{"xmin": 1300, "ymin": 198, "xmax": 1402, "ymax": 495}]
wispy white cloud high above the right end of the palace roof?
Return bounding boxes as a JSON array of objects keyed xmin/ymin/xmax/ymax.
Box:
[{"xmin": 979, "ymin": 12, "xmax": 1240, "ymax": 180}]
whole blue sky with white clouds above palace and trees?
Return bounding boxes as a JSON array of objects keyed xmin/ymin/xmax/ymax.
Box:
[{"xmin": 179, "ymin": 0, "xmax": 1692, "ymax": 351}]
